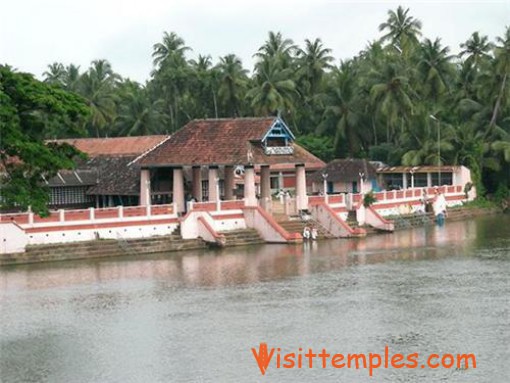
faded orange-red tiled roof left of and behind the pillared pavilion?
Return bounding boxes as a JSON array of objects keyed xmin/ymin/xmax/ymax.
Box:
[{"xmin": 57, "ymin": 135, "xmax": 168, "ymax": 157}]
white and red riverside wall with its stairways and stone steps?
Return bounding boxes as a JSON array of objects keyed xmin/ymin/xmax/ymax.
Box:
[{"xmin": 0, "ymin": 182, "xmax": 486, "ymax": 265}]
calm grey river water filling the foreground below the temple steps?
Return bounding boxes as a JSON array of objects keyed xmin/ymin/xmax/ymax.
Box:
[{"xmin": 0, "ymin": 216, "xmax": 510, "ymax": 383}]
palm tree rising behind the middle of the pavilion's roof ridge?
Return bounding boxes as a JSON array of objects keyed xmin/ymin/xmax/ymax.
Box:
[{"xmin": 217, "ymin": 54, "xmax": 248, "ymax": 117}]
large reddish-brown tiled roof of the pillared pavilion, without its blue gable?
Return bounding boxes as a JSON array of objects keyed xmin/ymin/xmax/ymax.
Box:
[{"xmin": 139, "ymin": 117, "xmax": 324, "ymax": 168}]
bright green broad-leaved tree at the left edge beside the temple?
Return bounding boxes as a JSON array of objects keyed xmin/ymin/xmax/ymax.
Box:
[{"xmin": 0, "ymin": 66, "xmax": 88, "ymax": 214}]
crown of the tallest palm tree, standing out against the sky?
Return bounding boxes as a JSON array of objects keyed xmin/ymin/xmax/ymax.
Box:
[{"xmin": 379, "ymin": 6, "xmax": 421, "ymax": 53}]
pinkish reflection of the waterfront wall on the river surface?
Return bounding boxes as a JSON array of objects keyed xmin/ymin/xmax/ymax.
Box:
[{"xmin": 0, "ymin": 220, "xmax": 494, "ymax": 292}]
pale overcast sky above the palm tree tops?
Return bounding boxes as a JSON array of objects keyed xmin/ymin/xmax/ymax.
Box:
[{"xmin": 0, "ymin": 0, "xmax": 510, "ymax": 83}]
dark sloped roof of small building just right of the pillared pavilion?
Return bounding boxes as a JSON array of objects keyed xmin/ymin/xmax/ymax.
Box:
[{"xmin": 311, "ymin": 158, "xmax": 377, "ymax": 182}]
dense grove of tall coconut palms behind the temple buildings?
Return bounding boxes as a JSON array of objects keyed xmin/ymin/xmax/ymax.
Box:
[{"xmin": 28, "ymin": 6, "xmax": 510, "ymax": 198}]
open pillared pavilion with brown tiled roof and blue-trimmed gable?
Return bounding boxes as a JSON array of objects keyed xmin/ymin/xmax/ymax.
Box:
[{"xmin": 138, "ymin": 117, "xmax": 325, "ymax": 212}]
